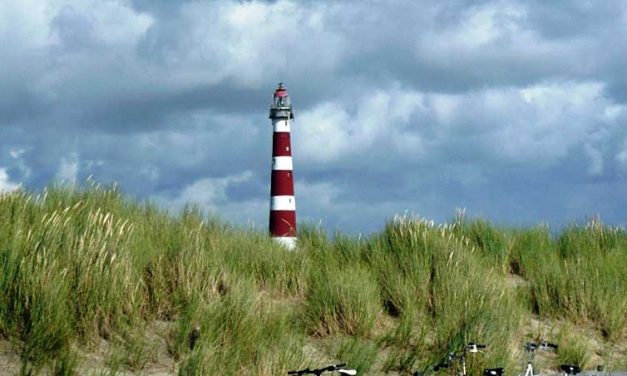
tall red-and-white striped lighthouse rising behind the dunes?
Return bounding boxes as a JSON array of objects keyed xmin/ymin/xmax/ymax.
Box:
[{"xmin": 270, "ymin": 83, "xmax": 296, "ymax": 250}]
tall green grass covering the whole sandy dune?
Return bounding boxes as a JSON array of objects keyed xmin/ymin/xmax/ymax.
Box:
[{"xmin": 0, "ymin": 185, "xmax": 627, "ymax": 375}]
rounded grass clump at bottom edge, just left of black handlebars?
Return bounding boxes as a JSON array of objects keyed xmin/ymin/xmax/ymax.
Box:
[{"xmin": 176, "ymin": 281, "xmax": 304, "ymax": 375}]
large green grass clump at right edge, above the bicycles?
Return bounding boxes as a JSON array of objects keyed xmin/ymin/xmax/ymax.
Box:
[{"xmin": 515, "ymin": 221, "xmax": 627, "ymax": 341}]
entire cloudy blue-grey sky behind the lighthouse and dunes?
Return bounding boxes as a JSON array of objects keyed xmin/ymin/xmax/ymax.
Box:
[{"xmin": 0, "ymin": 0, "xmax": 627, "ymax": 233}]
